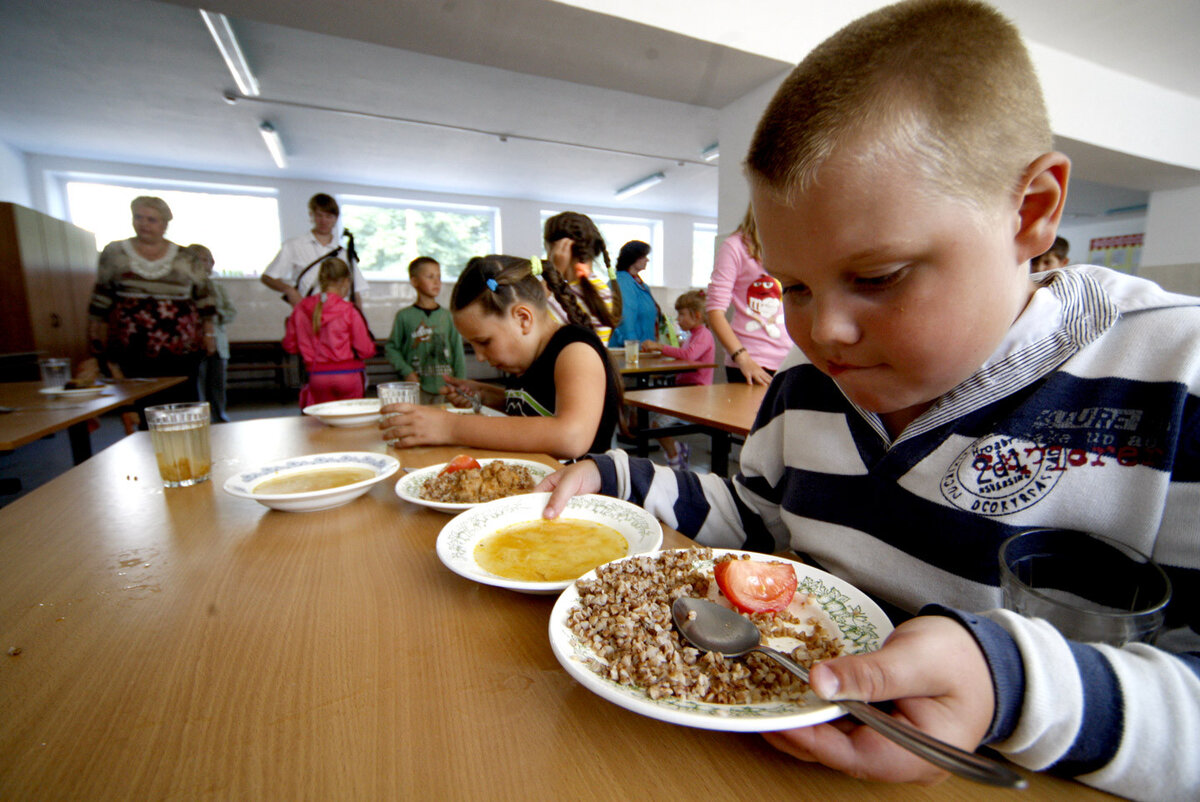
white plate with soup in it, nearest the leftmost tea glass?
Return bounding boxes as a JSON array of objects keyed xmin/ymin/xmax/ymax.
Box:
[{"xmin": 224, "ymin": 451, "xmax": 400, "ymax": 513}]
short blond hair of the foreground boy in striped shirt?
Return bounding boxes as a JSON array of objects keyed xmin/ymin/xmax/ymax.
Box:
[{"xmin": 745, "ymin": 0, "xmax": 1052, "ymax": 205}]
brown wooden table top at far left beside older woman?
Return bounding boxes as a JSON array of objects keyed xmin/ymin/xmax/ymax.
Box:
[{"xmin": 0, "ymin": 376, "xmax": 187, "ymax": 451}]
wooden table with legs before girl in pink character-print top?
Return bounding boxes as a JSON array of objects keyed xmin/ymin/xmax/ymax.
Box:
[{"xmin": 625, "ymin": 382, "xmax": 767, "ymax": 475}]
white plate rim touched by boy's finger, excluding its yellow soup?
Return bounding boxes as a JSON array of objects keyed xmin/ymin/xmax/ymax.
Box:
[{"xmin": 437, "ymin": 493, "xmax": 662, "ymax": 594}]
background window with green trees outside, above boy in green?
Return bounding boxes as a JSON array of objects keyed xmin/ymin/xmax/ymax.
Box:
[{"xmin": 338, "ymin": 196, "xmax": 500, "ymax": 280}]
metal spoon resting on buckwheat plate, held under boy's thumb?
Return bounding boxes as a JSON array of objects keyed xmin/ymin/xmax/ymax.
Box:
[{"xmin": 671, "ymin": 597, "xmax": 1026, "ymax": 788}]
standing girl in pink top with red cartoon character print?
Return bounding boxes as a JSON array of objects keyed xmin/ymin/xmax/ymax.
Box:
[{"xmin": 704, "ymin": 208, "xmax": 792, "ymax": 384}]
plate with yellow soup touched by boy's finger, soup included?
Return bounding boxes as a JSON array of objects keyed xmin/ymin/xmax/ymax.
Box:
[{"xmin": 437, "ymin": 493, "xmax": 662, "ymax": 593}]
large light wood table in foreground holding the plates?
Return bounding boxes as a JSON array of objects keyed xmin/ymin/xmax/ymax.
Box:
[{"xmin": 0, "ymin": 417, "xmax": 1100, "ymax": 800}]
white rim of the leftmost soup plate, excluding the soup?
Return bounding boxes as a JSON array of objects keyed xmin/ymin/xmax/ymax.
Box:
[{"xmin": 224, "ymin": 451, "xmax": 400, "ymax": 513}]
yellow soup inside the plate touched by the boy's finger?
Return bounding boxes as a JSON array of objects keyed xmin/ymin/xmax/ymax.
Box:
[{"xmin": 475, "ymin": 519, "xmax": 629, "ymax": 582}]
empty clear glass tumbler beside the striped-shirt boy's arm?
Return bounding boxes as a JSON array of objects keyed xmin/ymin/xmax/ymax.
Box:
[{"xmin": 1000, "ymin": 529, "xmax": 1171, "ymax": 646}]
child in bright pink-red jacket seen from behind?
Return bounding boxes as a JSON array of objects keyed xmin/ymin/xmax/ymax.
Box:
[{"xmin": 283, "ymin": 257, "xmax": 376, "ymax": 409}]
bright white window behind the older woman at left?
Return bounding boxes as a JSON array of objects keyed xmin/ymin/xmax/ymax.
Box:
[{"xmin": 62, "ymin": 175, "xmax": 280, "ymax": 276}]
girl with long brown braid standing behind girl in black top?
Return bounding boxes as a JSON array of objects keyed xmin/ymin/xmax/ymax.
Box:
[{"xmin": 542, "ymin": 211, "xmax": 622, "ymax": 347}]
